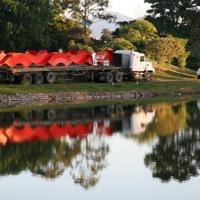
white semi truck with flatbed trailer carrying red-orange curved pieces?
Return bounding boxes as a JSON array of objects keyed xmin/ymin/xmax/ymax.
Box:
[{"xmin": 0, "ymin": 50, "xmax": 155, "ymax": 84}]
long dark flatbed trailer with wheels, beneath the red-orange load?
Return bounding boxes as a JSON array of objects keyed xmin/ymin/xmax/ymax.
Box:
[{"xmin": 0, "ymin": 65, "xmax": 144, "ymax": 84}]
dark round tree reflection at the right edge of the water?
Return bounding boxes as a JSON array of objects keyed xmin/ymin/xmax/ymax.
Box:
[{"xmin": 145, "ymin": 104, "xmax": 200, "ymax": 182}]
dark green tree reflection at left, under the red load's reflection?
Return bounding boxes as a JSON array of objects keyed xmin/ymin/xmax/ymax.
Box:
[{"xmin": 0, "ymin": 140, "xmax": 80, "ymax": 179}]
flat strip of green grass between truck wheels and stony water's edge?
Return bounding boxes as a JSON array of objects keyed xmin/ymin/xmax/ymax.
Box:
[{"xmin": 0, "ymin": 80, "xmax": 200, "ymax": 94}]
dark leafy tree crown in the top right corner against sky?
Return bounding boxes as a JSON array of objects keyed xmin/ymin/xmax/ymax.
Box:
[{"xmin": 145, "ymin": 0, "xmax": 200, "ymax": 36}]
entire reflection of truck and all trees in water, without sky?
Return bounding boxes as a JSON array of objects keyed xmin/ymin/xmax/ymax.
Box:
[{"xmin": 0, "ymin": 102, "xmax": 200, "ymax": 189}]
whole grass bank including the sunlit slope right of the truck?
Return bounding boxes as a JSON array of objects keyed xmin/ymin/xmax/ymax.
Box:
[{"xmin": 0, "ymin": 65, "xmax": 200, "ymax": 95}]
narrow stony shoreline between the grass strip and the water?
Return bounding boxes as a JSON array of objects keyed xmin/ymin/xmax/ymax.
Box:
[{"xmin": 0, "ymin": 90, "xmax": 200, "ymax": 106}]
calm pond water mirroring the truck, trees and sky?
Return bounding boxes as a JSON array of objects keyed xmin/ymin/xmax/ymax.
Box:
[{"xmin": 0, "ymin": 101, "xmax": 200, "ymax": 200}]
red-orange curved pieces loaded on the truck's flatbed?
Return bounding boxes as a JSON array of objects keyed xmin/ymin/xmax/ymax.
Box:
[{"xmin": 0, "ymin": 50, "xmax": 113, "ymax": 68}]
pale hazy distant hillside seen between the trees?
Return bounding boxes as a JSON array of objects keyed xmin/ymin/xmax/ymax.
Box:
[{"xmin": 91, "ymin": 12, "xmax": 133, "ymax": 38}]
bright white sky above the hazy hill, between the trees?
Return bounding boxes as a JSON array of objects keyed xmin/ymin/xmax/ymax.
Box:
[{"xmin": 109, "ymin": 0, "xmax": 149, "ymax": 18}]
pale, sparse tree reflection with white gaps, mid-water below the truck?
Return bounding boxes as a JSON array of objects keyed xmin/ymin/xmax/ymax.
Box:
[{"xmin": 71, "ymin": 134, "xmax": 109, "ymax": 189}]
